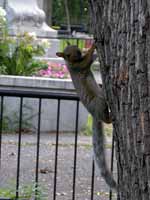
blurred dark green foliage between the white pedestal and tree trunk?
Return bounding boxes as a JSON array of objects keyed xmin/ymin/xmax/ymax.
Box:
[{"xmin": 52, "ymin": 0, "xmax": 90, "ymax": 32}]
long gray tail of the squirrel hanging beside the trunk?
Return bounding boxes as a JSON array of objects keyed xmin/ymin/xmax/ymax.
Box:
[{"xmin": 93, "ymin": 119, "xmax": 117, "ymax": 190}]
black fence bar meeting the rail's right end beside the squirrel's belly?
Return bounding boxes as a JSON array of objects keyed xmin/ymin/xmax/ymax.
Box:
[{"xmin": 72, "ymin": 101, "xmax": 79, "ymax": 200}]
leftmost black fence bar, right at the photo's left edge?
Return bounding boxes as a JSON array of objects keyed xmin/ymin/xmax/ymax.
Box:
[{"xmin": 0, "ymin": 96, "xmax": 4, "ymax": 168}]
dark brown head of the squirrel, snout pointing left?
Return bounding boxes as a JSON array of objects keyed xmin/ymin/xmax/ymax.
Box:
[{"xmin": 56, "ymin": 45, "xmax": 82, "ymax": 64}]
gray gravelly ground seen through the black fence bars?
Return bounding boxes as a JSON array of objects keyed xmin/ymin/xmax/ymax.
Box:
[{"xmin": 0, "ymin": 134, "xmax": 116, "ymax": 200}]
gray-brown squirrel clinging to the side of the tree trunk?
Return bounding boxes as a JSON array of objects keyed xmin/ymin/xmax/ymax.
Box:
[{"xmin": 56, "ymin": 44, "xmax": 117, "ymax": 190}]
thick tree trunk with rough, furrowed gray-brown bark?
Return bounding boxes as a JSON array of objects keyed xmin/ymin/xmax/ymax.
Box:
[{"xmin": 89, "ymin": 0, "xmax": 150, "ymax": 200}]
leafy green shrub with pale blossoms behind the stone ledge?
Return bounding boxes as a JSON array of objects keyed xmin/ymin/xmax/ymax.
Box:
[{"xmin": 0, "ymin": 6, "xmax": 47, "ymax": 76}]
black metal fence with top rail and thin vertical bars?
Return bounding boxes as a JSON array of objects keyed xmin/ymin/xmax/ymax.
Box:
[{"xmin": 0, "ymin": 90, "xmax": 114, "ymax": 200}]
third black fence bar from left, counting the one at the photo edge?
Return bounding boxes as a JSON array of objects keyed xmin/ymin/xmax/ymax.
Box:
[{"xmin": 35, "ymin": 98, "xmax": 42, "ymax": 200}]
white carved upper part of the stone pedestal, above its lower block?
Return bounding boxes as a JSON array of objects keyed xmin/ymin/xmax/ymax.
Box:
[{"xmin": 6, "ymin": 0, "xmax": 57, "ymax": 37}]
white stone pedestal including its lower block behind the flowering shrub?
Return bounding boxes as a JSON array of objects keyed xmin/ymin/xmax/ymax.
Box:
[{"xmin": 0, "ymin": 0, "xmax": 60, "ymax": 59}]
